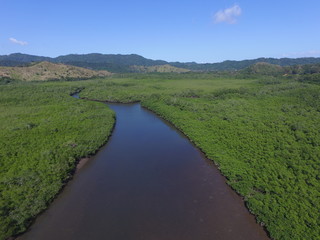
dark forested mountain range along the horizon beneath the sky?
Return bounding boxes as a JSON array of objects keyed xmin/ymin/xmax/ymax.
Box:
[{"xmin": 0, "ymin": 53, "xmax": 320, "ymax": 73}]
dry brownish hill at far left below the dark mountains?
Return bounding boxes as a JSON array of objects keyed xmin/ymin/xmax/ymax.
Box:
[{"xmin": 0, "ymin": 62, "xmax": 111, "ymax": 81}]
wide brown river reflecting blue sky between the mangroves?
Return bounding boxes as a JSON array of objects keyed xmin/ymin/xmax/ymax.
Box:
[{"xmin": 19, "ymin": 104, "xmax": 268, "ymax": 240}]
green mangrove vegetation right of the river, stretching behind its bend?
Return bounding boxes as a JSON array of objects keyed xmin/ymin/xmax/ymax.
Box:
[{"xmin": 80, "ymin": 74, "xmax": 320, "ymax": 240}]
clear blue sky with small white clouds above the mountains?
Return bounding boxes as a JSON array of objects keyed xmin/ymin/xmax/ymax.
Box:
[{"xmin": 0, "ymin": 0, "xmax": 320, "ymax": 63}]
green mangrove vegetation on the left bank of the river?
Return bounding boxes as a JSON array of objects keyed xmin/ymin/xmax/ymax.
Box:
[{"xmin": 0, "ymin": 82, "xmax": 114, "ymax": 239}]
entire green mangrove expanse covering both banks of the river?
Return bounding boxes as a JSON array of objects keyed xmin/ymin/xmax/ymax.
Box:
[{"xmin": 0, "ymin": 73, "xmax": 320, "ymax": 239}]
